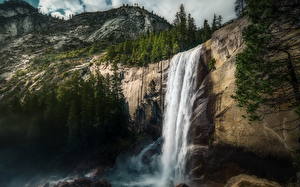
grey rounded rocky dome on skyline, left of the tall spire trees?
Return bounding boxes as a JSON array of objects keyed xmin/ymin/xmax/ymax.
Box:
[{"xmin": 75, "ymin": 6, "xmax": 170, "ymax": 42}]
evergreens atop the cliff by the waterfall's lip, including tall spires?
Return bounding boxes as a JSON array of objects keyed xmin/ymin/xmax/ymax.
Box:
[{"xmin": 105, "ymin": 5, "xmax": 222, "ymax": 66}]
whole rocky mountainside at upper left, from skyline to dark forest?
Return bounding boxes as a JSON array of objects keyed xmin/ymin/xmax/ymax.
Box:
[{"xmin": 0, "ymin": 1, "xmax": 171, "ymax": 100}]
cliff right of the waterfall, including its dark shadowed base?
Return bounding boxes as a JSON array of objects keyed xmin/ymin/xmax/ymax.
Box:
[{"xmin": 188, "ymin": 18, "xmax": 300, "ymax": 185}]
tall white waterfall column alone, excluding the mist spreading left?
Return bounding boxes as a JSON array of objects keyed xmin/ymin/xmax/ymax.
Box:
[{"xmin": 160, "ymin": 46, "xmax": 202, "ymax": 186}]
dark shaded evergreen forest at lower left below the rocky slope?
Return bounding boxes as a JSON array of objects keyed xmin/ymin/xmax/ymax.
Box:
[{"xmin": 0, "ymin": 72, "xmax": 132, "ymax": 151}]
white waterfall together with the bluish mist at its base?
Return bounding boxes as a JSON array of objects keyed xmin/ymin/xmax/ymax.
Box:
[{"xmin": 106, "ymin": 46, "xmax": 202, "ymax": 187}]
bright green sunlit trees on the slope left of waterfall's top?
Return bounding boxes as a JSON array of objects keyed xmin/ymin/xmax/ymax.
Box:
[{"xmin": 106, "ymin": 26, "xmax": 192, "ymax": 66}]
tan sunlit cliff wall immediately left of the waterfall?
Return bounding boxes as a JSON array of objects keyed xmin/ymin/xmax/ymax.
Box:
[{"xmin": 91, "ymin": 60, "xmax": 169, "ymax": 139}]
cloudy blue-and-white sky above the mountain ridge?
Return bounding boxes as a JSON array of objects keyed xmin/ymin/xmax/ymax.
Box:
[{"xmin": 0, "ymin": 0, "xmax": 235, "ymax": 27}]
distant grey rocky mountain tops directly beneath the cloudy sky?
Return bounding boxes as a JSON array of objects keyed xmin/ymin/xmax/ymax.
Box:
[{"xmin": 0, "ymin": 1, "xmax": 170, "ymax": 42}]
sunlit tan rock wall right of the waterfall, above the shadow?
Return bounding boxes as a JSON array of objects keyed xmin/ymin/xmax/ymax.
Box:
[{"xmin": 205, "ymin": 19, "xmax": 300, "ymax": 158}]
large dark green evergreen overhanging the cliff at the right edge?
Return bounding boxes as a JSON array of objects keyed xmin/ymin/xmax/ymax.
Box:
[{"xmin": 234, "ymin": 0, "xmax": 300, "ymax": 120}]
